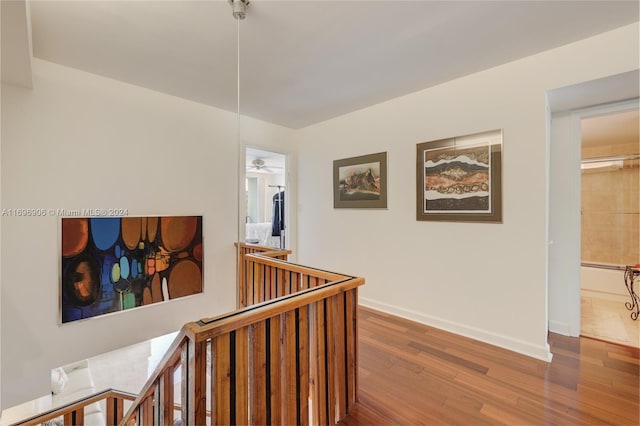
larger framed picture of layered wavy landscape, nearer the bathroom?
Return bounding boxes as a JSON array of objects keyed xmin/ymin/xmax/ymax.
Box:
[{"xmin": 416, "ymin": 130, "xmax": 502, "ymax": 223}]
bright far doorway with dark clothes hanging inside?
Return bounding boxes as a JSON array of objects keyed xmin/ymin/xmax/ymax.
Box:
[{"xmin": 245, "ymin": 147, "xmax": 289, "ymax": 248}]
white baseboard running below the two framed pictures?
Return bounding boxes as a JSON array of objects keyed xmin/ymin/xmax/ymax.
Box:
[{"xmin": 359, "ymin": 296, "xmax": 553, "ymax": 362}]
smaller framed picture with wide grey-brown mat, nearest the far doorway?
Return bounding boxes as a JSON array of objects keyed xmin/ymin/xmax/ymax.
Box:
[{"xmin": 333, "ymin": 152, "xmax": 387, "ymax": 209}]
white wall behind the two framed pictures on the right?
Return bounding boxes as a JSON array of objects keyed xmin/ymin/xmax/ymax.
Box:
[{"xmin": 295, "ymin": 23, "xmax": 638, "ymax": 359}]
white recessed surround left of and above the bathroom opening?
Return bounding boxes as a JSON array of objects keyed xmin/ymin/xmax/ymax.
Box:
[{"xmin": 547, "ymin": 74, "xmax": 640, "ymax": 337}]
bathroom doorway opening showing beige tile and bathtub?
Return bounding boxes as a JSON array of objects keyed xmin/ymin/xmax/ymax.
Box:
[{"xmin": 580, "ymin": 108, "xmax": 640, "ymax": 347}]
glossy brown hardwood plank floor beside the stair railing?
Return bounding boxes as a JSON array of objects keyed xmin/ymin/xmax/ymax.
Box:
[{"xmin": 343, "ymin": 308, "xmax": 640, "ymax": 426}]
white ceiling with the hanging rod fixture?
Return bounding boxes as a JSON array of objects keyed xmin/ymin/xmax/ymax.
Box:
[{"xmin": 3, "ymin": 0, "xmax": 639, "ymax": 128}]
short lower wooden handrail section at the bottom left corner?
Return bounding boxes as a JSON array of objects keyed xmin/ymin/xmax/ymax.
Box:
[{"xmin": 11, "ymin": 389, "xmax": 136, "ymax": 426}]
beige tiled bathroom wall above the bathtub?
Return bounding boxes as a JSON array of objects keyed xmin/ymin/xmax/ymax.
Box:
[{"xmin": 582, "ymin": 142, "xmax": 640, "ymax": 265}]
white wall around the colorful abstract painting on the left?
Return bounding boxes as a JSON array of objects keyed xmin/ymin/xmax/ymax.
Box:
[{"xmin": 1, "ymin": 60, "xmax": 291, "ymax": 407}]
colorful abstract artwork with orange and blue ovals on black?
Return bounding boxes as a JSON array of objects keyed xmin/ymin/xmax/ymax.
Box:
[{"xmin": 61, "ymin": 216, "xmax": 203, "ymax": 323}]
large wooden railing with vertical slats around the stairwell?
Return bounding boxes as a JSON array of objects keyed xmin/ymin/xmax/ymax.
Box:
[{"xmin": 121, "ymin": 244, "xmax": 364, "ymax": 425}]
